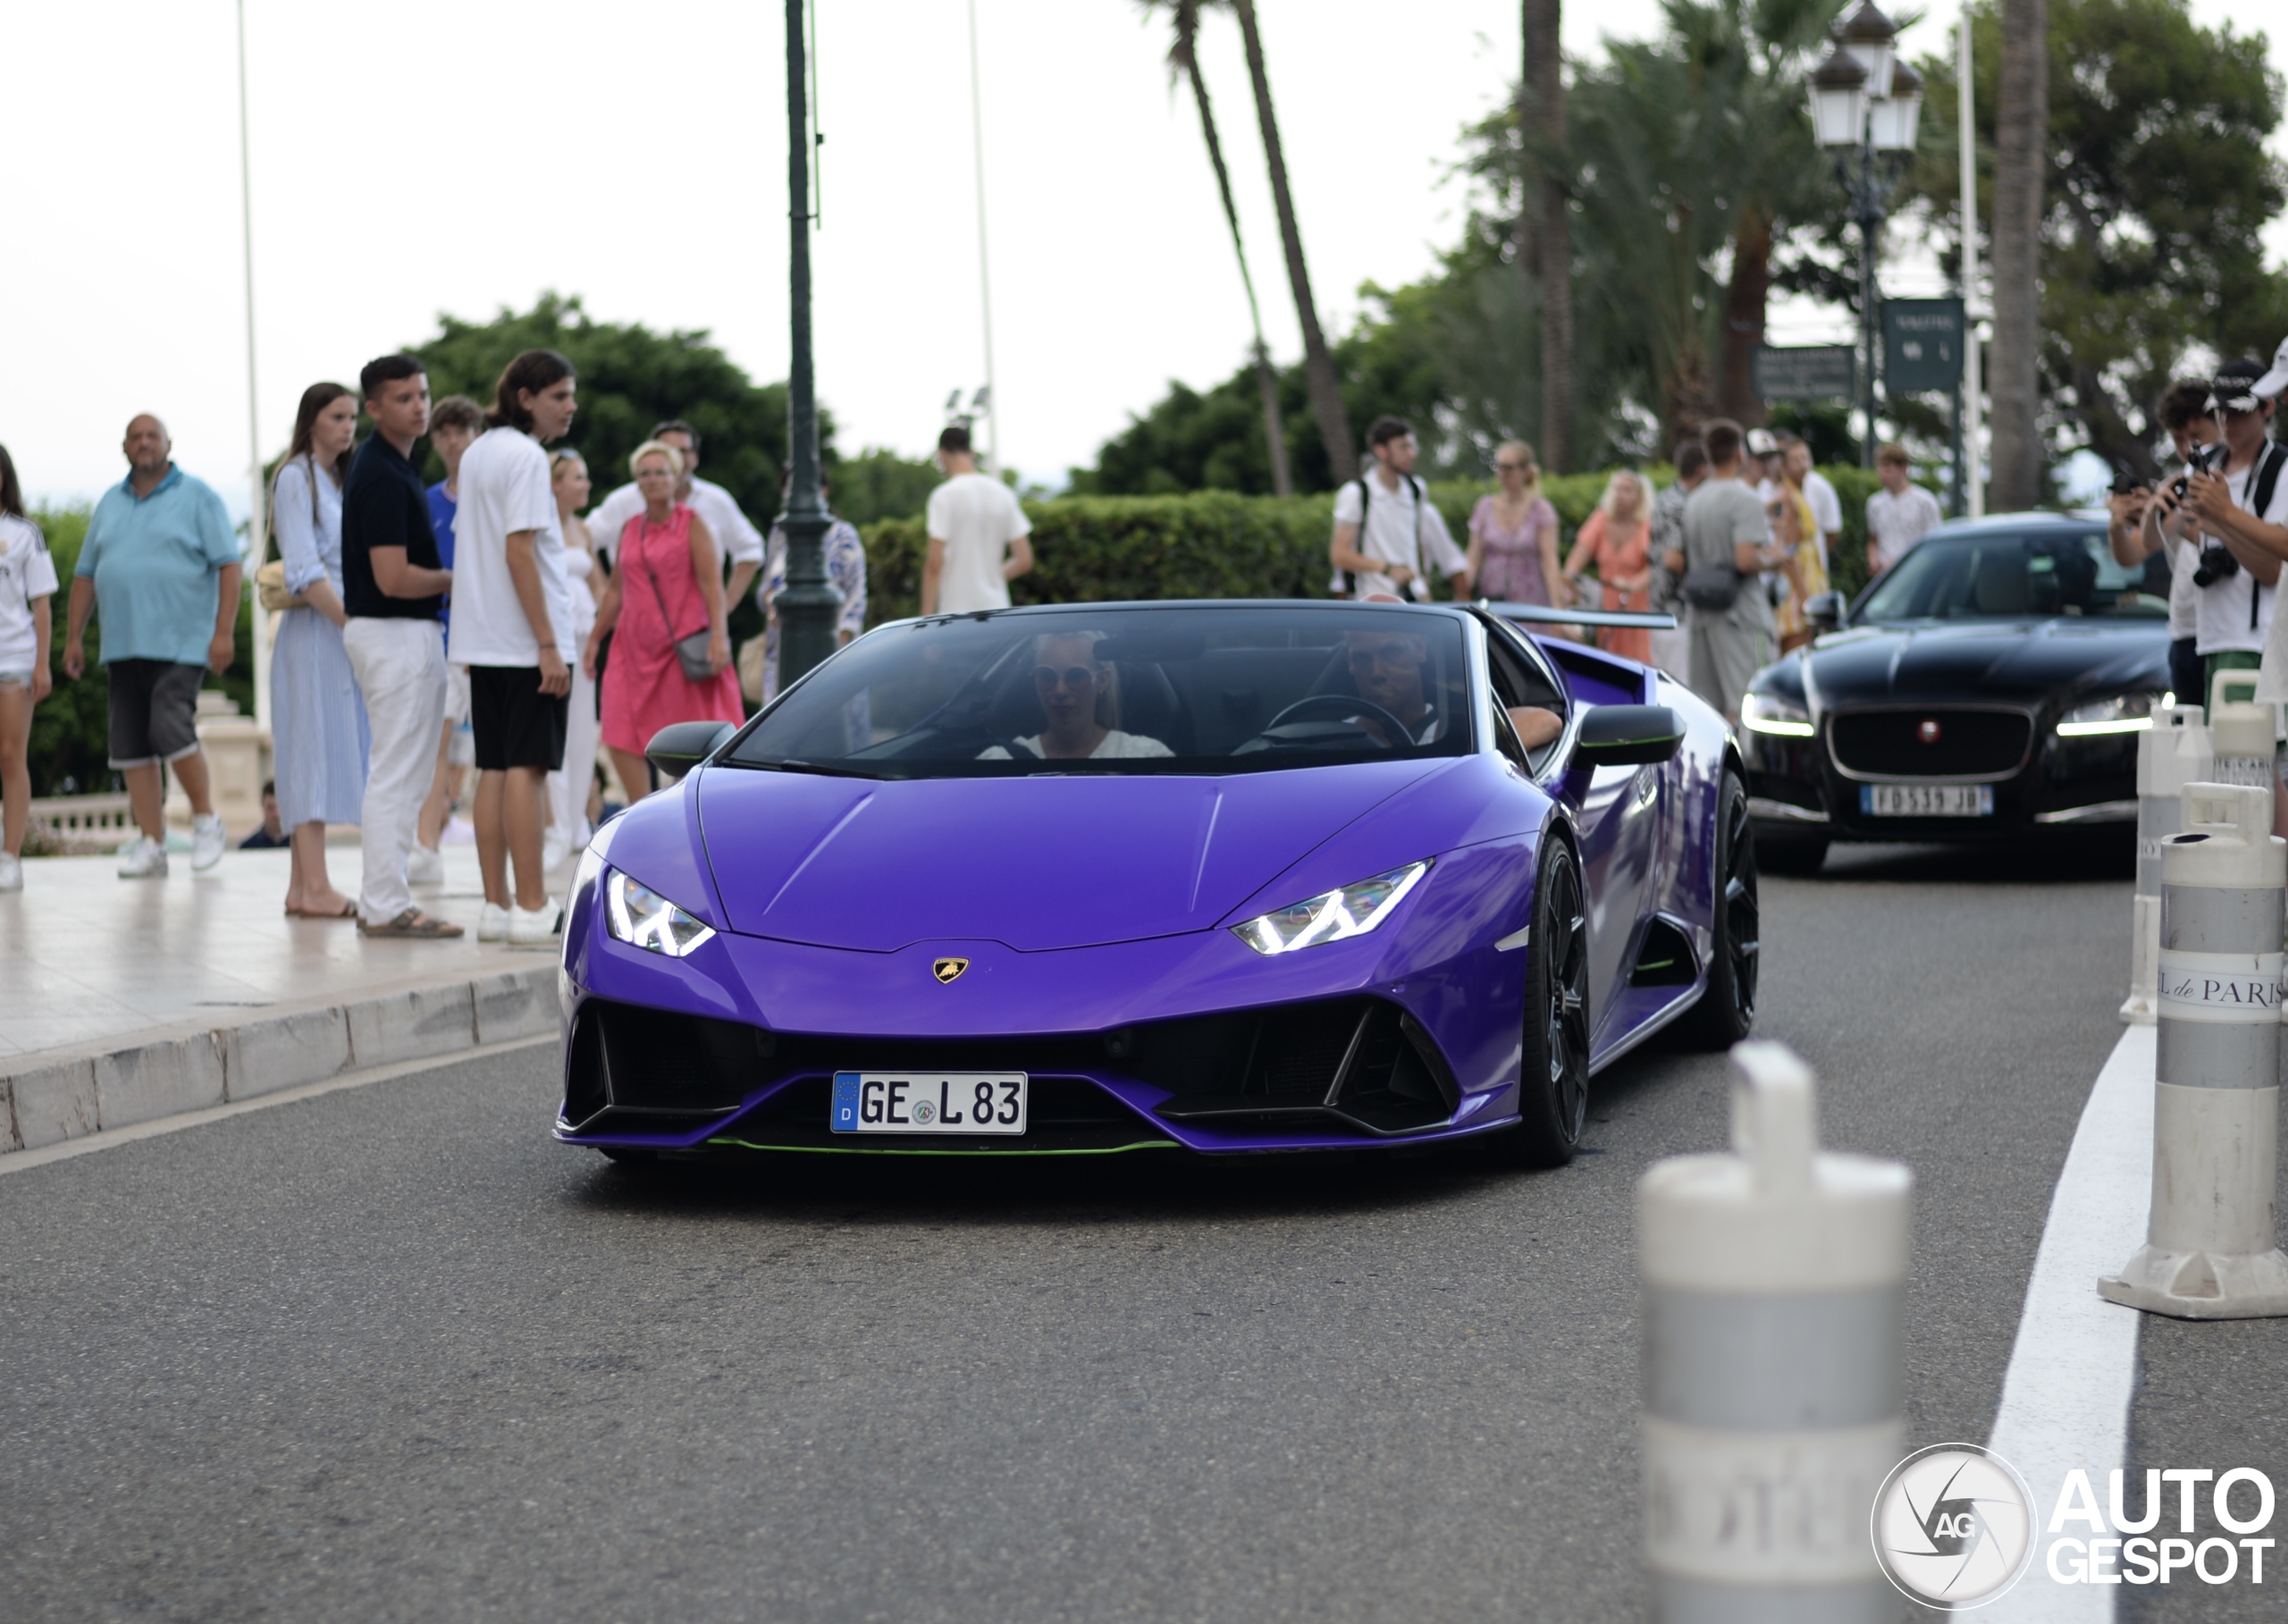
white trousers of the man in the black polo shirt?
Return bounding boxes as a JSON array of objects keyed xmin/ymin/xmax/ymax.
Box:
[{"xmin": 341, "ymin": 618, "xmax": 444, "ymax": 924}]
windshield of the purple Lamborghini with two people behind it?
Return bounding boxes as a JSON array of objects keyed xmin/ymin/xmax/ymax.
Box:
[{"xmin": 726, "ymin": 604, "xmax": 1471, "ymax": 778}]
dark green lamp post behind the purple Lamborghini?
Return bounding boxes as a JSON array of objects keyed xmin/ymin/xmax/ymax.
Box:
[{"xmin": 778, "ymin": 0, "xmax": 842, "ymax": 691}]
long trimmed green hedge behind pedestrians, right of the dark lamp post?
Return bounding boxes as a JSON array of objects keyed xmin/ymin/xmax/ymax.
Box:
[{"xmin": 862, "ymin": 467, "xmax": 1876, "ymax": 625}]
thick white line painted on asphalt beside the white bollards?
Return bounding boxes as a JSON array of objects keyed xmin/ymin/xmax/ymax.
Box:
[{"xmin": 1986, "ymin": 1027, "xmax": 2158, "ymax": 1624}]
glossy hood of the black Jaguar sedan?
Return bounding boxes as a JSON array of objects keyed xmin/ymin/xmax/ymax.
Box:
[{"xmin": 1798, "ymin": 618, "xmax": 2169, "ymax": 709}]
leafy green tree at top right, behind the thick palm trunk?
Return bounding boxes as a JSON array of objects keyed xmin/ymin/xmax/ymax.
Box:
[{"xmin": 1915, "ymin": 0, "xmax": 2288, "ymax": 480}]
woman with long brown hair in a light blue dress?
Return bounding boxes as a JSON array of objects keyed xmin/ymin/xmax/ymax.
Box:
[{"xmin": 270, "ymin": 384, "xmax": 373, "ymax": 920}]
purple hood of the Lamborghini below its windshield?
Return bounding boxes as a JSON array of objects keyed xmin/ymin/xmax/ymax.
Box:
[{"xmin": 698, "ymin": 760, "xmax": 1443, "ymax": 954}]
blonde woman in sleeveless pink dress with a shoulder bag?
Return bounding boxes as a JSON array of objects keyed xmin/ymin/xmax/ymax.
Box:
[{"xmin": 581, "ymin": 439, "xmax": 746, "ymax": 801}]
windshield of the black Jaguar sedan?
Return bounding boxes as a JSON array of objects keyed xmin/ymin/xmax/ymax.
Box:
[{"xmin": 1854, "ymin": 526, "xmax": 2169, "ymax": 622}]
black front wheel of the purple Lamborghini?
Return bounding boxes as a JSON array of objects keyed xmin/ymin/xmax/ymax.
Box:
[{"xmin": 1503, "ymin": 837, "xmax": 1590, "ymax": 1166}]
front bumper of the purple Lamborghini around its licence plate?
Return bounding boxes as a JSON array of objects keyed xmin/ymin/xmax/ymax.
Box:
[{"xmin": 554, "ymin": 851, "xmax": 1524, "ymax": 1155}]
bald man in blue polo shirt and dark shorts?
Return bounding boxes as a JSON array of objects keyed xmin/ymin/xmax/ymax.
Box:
[{"xmin": 64, "ymin": 412, "xmax": 240, "ymax": 880}]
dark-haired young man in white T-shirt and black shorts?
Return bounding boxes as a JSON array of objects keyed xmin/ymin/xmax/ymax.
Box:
[{"xmin": 449, "ymin": 350, "xmax": 579, "ymax": 947}]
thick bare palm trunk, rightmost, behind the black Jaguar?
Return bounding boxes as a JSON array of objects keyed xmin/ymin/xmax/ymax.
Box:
[{"xmin": 1989, "ymin": 0, "xmax": 2050, "ymax": 512}]
